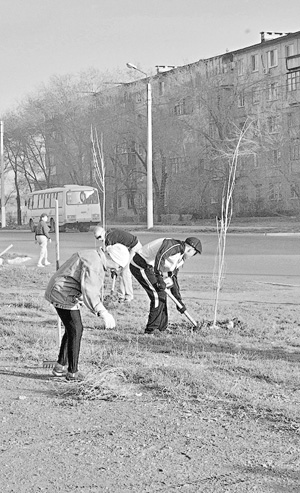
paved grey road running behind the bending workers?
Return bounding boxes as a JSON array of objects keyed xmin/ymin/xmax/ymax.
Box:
[{"xmin": 0, "ymin": 230, "xmax": 300, "ymax": 286}]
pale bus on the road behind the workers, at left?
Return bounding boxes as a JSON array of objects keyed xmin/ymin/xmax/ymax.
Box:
[{"xmin": 27, "ymin": 185, "xmax": 101, "ymax": 232}]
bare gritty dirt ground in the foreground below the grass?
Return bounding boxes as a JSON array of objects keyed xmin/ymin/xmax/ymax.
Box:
[{"xmin": 0, "ymin": 365, "xmax": 300, "ymax": 493}]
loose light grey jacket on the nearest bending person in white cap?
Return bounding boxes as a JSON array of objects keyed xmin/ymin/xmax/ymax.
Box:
[{"xmin": 45, "ymin": 249, "xmax": 107, "ymax": 314}]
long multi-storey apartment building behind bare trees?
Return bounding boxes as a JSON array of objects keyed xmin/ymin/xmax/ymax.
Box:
[{"xmin": 108, "ymin": 31, "xmax": 300, "ymax": 217}]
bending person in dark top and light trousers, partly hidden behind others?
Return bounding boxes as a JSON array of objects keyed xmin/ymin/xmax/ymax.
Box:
[{"xmin": 94, "ymin": 226, "xmax": 142, "ymax": 303}]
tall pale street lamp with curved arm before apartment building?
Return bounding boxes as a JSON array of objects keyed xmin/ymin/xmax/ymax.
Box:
[{"xmin": 126, "ymin": 63, "xmax": 153, "ymax": 229}]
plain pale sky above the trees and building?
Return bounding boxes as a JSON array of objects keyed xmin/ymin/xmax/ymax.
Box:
[{"xmin": 0, "ymin": 0, "xmax": 300, "ymax": 114}]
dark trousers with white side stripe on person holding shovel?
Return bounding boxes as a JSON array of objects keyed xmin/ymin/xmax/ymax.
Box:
[{"xmin": 130, "ymin": 264, "xmax": 168, "ymax": 334}]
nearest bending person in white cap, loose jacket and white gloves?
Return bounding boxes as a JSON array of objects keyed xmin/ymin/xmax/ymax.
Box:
[{"xmin": 45, "ymin": 243, "xmax": 129, "ymax": 381}]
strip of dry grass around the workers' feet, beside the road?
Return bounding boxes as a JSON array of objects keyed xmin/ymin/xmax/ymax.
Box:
[{"xmin": 0, "ymin": 266, "xmax": 300, "ymax": 431}]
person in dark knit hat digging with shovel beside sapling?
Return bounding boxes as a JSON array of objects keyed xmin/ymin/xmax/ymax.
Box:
[{"xmin": 130, "ymin": 237, "xmax": 202, "ymax": 334}]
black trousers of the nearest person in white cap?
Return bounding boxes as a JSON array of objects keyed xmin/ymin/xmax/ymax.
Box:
[{"xmin": 55, "ymin": 308, "xmax": 83, "ymax": 373}]
